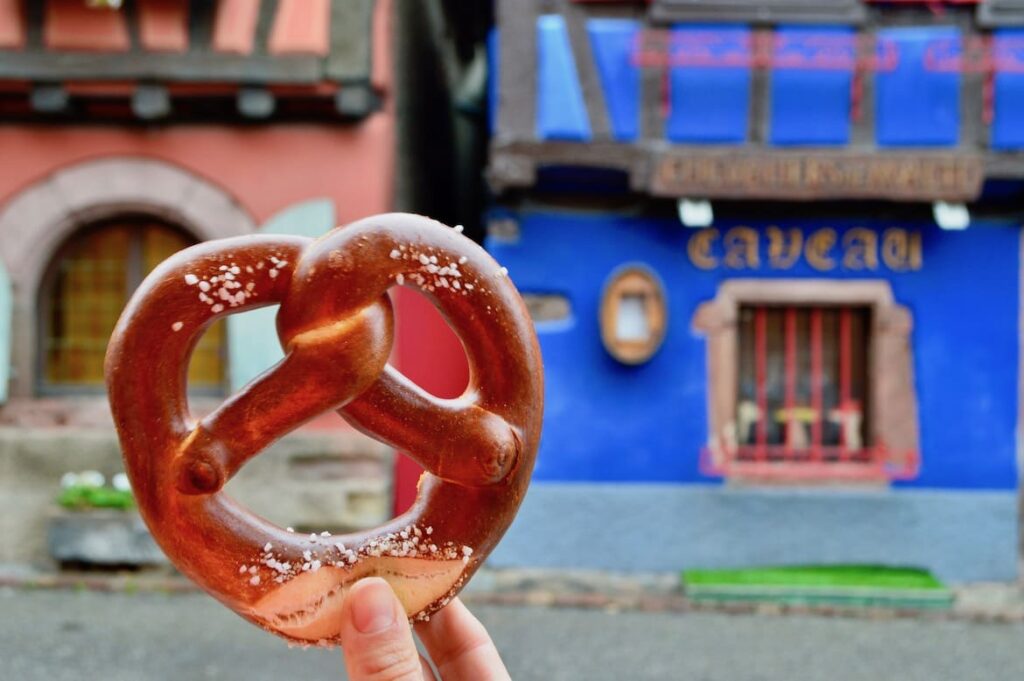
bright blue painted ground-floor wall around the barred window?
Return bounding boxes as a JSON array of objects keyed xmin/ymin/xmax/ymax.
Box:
[{"xmin": 488, "ymin": 213, "xmax": 1020, "ymax": 490}]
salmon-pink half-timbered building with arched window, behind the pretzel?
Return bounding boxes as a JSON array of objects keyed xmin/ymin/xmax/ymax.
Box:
[{"xmin": 0, "ymin": 0, "xmax": 483, "ymax": 564}]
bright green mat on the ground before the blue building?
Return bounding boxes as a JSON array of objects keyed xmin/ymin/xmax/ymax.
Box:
[{"xmin": 683, "ymin": 565, "xmax": 953, "ymax": 609}]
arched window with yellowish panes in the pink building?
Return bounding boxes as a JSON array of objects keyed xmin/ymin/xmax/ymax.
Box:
[{"xmin": 39, "ymin": 217, "xmax": 224, "ymax": 392}]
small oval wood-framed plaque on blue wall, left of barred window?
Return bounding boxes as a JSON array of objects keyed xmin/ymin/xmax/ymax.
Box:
[{"xmin": 600, "ymin": 265, "xmax": 668, "ymax": 365}]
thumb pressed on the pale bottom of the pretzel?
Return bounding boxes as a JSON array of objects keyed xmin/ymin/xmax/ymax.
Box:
[{"xmin": 341, "ymin": 578, "xmax": 423, "ymax": 681}]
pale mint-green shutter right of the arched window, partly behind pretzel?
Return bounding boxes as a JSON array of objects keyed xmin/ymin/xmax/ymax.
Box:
[{"xmin": 228, "ymin": 199, "xmax": 335, "ymax": 391}]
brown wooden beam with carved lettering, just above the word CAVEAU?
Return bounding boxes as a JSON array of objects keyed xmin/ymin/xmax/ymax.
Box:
[{"xmin": 487, "ymin": 140, "xmax": 995, "ymax": 201}]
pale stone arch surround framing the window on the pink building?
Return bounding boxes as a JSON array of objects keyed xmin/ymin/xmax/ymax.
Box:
[{"xmin": 0, "ymin": 157, "xmax": 256, "ymax": 397}]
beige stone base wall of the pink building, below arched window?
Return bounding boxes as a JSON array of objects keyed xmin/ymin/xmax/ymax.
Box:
[{"xmin": 0, "ymin": 426, "xmax": 392, "ymax": 568}]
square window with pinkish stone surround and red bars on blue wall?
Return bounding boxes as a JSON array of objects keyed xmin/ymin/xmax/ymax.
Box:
[{"xmin": 693, "ymin": 280, "xmax": 920, "ymax": 483}]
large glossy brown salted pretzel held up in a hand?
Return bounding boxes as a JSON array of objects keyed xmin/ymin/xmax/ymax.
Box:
[{"xmin": 105, "ymin": 214, "xmax": 543, "ymax": 645}]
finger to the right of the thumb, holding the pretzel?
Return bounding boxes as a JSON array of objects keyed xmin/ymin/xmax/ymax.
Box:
[{"xmin": 416, "ymin": 598, "xmax": 510, "ymax": 681}]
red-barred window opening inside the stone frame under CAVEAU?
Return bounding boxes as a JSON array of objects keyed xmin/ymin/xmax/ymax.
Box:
[{"xmin": 734, "ymin": 306, "xmax": 877, "ymax": 472}]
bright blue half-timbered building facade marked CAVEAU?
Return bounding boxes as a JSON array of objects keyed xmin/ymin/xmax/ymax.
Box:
[{"xmin": 487, "ymin": 0, "xmax": 1024, "ymax": 581}]
